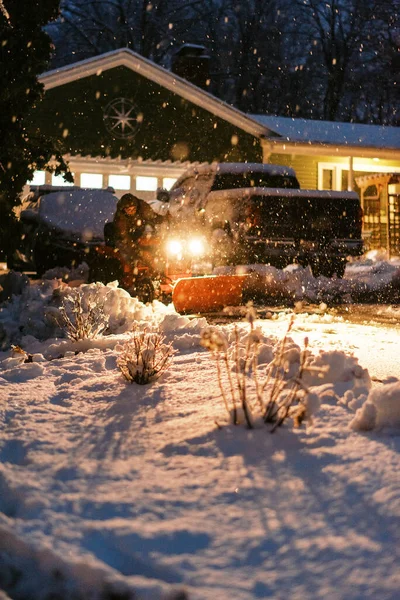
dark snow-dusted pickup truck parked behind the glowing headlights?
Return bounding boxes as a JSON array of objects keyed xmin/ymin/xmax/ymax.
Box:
[{"xmin": 164, "ymin": 163, "xmax": 363, "ymax": 277}]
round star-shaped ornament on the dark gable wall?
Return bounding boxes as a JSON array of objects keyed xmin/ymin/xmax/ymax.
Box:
[{"xmin": 104, "ymin": 98, "xmax": 143, "ymax": 139}]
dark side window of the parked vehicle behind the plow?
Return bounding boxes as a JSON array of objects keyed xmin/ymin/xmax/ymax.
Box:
[{"xmin": 212, "ymin": 171, "xmax": 300, "ymax": 191}]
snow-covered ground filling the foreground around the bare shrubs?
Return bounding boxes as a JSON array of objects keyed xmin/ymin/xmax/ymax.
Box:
[{"xmin": 0, "ymin": 257, "xmax": 400, "ymax": 600}]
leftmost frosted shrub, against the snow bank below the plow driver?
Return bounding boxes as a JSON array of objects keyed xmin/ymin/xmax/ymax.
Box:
[{"xmin": 57, "ymin": 288, "xmax": 109, "ymax": 342}]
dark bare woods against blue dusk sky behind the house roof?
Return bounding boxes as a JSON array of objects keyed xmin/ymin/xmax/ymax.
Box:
[{"xmin": 43, "ymin": 0, "xmax": 400, "ymax": 124}]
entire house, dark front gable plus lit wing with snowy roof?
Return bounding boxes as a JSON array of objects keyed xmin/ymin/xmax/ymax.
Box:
[{"xmin": 30, "ymin": 46, "xmax": 400, "ymax": 250}]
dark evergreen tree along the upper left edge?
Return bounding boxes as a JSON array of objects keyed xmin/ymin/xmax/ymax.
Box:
[{"xmin": 0, "ymin": 0, "xmax": 72, "ymax": 254}]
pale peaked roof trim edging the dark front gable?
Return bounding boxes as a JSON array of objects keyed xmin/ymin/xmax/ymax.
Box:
[{"xmin": 39, "ymin": 48, "xmax": 271, "ymax": 137}]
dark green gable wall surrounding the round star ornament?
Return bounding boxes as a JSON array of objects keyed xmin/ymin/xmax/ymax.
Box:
[{"xmin": 33, "ymin": 67, "xmax": 262, "ymax": 162}]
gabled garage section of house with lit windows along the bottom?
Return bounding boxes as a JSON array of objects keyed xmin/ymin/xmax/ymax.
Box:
[{"xmin": 34, "ymin": 49, "xmax": 269, "ymax": 199}]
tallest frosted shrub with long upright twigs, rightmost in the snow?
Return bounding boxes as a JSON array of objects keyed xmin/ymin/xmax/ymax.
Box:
[{"xmin": 201, "ymin": 311, "xmax": 320, "ymax": 432}]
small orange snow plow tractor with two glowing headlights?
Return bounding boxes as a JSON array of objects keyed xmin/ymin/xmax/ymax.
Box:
[{"xmin": 90, "ymin": 225, "xmax": 256, "ymax": 314}]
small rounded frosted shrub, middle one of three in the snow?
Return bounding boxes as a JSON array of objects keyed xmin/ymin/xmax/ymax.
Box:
[{"xmin": 117, "ymin": 330, "xmax": 174, "ymax": 385}]
